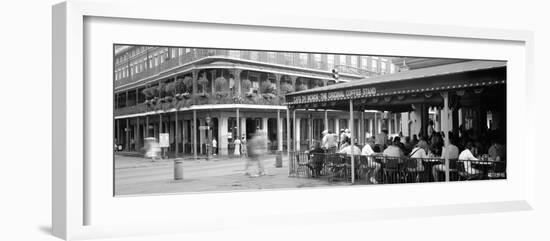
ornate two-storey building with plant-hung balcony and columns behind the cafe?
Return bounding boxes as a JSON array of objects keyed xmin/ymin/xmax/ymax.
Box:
[{"xmin": 113, "ymin": 46, "xmax": 400, "ymax": 156}]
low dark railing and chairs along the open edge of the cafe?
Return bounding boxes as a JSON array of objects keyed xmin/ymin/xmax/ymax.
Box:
[{"xmin": 289, "ymin": 151, "xmax": 506, "ymax": 184}]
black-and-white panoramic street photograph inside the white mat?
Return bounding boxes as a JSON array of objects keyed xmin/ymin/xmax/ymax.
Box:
[{"xmin": 112, "ymin": 44, "xmax": 507, "ymax": 196}]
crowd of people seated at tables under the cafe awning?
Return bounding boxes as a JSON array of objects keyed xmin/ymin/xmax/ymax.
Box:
[{"xmin": 309, "ymin": 123, "xmax": 506, "ymax": 183}]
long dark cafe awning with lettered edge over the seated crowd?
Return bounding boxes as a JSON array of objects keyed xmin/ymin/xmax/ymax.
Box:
[{"xmin": 286, "ymin": 60, "xmax": 506, "ymax": 111}]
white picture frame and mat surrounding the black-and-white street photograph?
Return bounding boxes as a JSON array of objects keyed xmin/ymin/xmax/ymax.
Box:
[{"xmin": 52, "ymin": 0, "xmax": 535, "ymax": 239}]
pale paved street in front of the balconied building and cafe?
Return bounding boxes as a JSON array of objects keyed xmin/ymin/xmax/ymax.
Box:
[{"xmin": 115, "ymin": 155, "xmax": 349, "ymax": 195}]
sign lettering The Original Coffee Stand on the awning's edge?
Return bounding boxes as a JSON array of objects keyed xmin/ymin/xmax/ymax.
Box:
[{"xmin": 294, "ymin": 87, "xmax": 376, "ymax": 102}]
